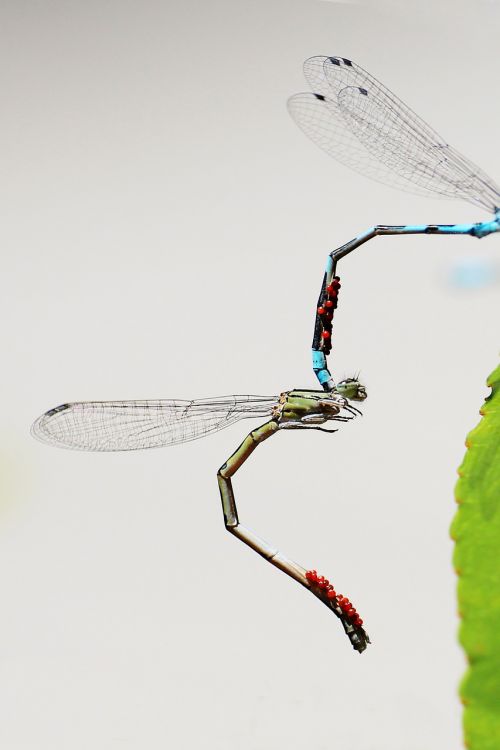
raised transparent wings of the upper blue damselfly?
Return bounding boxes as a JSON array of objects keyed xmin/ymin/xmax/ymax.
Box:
[{"xmin": 288, "ymin": 57, "xmax": 500, "ymax": 212}]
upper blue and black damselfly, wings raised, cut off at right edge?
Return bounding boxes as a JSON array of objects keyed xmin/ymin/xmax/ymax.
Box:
[{"xmin": 288, "ymin": 56, "xmax": 500, "ymax": 391}]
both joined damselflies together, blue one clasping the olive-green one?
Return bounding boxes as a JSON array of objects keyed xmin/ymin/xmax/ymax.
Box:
[{"xmin": 33, "ymin": 57, "xmax": 500, "ymax": 652}]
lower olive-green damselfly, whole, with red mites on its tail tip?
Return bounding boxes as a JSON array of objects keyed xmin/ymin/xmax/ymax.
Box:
[{"xmin": 32, "ymin": 378, "xmax": 369, "ymax": 652}]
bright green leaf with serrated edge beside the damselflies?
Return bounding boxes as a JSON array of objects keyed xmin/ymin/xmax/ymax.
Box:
[{"xmin": 451, "ymin": 367, "xmax": 500, "ymax": 750}]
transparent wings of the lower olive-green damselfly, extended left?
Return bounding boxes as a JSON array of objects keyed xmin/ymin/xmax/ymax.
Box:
[{"xmin": 31, "ymin": 396, "xmax": 278, "ymax": 451}]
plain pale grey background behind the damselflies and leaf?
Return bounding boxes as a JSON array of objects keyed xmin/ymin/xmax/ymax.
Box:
[{"xmin": 0, "ymin": 0, "xmax": 500, "ymax": 750}]
